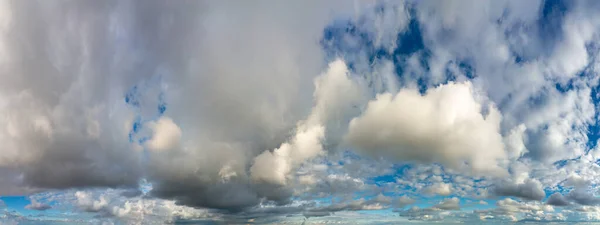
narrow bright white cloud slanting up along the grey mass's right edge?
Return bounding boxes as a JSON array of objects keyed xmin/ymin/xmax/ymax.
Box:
[{"xmin": 250, "ymin": 60, "xmax": 359, "ymax": 185}]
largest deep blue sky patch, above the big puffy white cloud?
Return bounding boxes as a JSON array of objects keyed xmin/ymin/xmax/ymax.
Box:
[{"xmin": 320, "ymin": 4, "xmax": 476, "ymax": 94}]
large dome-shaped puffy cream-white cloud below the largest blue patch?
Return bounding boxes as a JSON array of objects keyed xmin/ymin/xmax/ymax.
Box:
[{"xmin": 346, "ymin": 82, "xmax": 506, "ymax": 175}]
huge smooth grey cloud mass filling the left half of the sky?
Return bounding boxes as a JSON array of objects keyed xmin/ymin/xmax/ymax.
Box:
[{"xmin": 0, "ymin": 0, "xmax": 354, "ymax": 211}]
